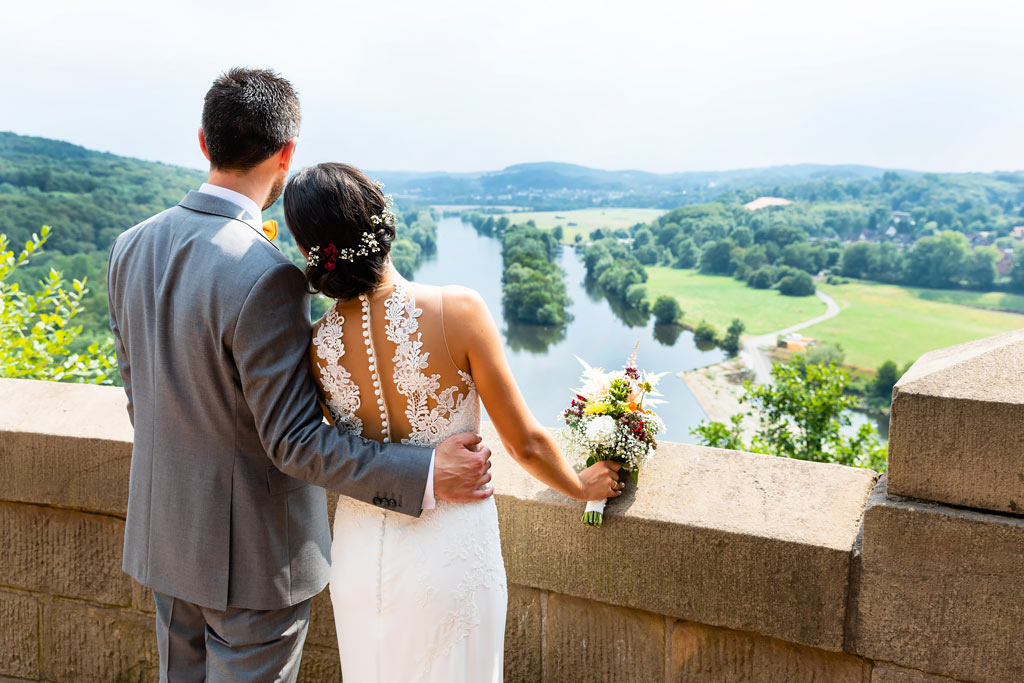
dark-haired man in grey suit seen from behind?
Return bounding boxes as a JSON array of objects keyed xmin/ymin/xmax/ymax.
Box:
[{"xmin": 108, "ymin": 69, "xmax": 490, "ymax": 681}]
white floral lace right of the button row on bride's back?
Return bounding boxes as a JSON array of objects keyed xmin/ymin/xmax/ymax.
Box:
[{"xmin": 385, "ymin": 285, "xmax": 479, "ymax": 446}]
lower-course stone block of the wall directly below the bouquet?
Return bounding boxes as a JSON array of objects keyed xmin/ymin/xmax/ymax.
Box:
[{"xmin": 535, "ymin": 595, "xmax": 666, "ymax": 683}]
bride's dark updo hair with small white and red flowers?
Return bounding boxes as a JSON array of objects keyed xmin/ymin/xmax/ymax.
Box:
[{"xmin": 285, "ymin": 164, "xmax": 394, "ymax": 300}]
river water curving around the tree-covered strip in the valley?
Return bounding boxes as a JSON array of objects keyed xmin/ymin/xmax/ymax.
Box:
[{"xmin": 416, "ymin": 217, "xmax": 725, "ymax": 442}]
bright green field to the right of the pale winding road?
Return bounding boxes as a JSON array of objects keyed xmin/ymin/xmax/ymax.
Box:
[{"xmin": 802, "ymin": 283, "xmax": 1024, "ymax": 369}]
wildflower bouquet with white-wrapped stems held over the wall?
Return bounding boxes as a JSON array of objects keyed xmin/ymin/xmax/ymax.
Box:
[{"xmin": 562, "ymin": 344, "xmax": 667, "ymax": 526}]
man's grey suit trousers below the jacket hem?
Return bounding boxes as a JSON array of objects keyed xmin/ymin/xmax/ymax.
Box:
[{"xmin": 153, "ymin": 591, "xmax": 311, "ymax": 683}]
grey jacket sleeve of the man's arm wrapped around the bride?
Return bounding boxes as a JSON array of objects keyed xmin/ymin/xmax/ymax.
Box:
[{"xmin": 232, "ymin": 263, "xmax": 431, "ymax": 516}]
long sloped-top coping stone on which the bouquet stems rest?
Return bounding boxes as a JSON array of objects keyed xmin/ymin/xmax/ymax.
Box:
[{"xmin": 482, "ymin": 424, "xmax": 877, "ymax": 651}]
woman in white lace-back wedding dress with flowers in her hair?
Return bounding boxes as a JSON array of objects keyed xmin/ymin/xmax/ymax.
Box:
[{"xmin": 285, "ymin": 164, "xmax": 622, "ymax": 683}]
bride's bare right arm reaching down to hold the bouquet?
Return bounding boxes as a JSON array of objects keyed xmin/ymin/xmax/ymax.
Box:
[{"xmin": 441, "ymin": 287, "xmax": 620, "ymax": 501}]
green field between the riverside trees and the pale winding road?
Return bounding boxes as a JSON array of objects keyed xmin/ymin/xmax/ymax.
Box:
[{"xmin": 646, "ymin": 266, "xmax": 825, "ymax": 335}]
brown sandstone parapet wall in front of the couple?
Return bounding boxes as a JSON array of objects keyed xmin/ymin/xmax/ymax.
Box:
[{"xmin": 0, "ymin": 333, "xmax": 1024, "ymax": 683}]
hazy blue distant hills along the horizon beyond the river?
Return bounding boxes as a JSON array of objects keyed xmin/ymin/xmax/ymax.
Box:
[{"xmin": 373, "ymin": 162, "xmax": 912, "ymax": 210}]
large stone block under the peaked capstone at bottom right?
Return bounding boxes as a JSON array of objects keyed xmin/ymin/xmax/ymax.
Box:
[{"xmin": 851, "ymin": 480, "xmax": 1024, "ymax": 683}]
